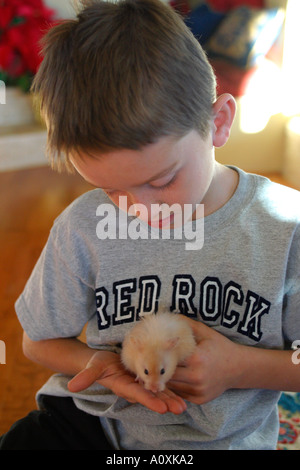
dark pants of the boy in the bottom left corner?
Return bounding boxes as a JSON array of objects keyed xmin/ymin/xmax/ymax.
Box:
[{"xmin": 0, "ymin": 395, "xmax": 112, "ymax": 450}]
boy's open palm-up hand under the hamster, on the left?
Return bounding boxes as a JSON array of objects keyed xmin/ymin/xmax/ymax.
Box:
[{"xmin": 68, "ymin": 351, "xmax": 186, "ymax": 414}]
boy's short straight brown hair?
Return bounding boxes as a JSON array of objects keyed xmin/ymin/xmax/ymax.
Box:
[{"xmin": 32, "ymin": 0, "xmax": 216, "ymax": 173}]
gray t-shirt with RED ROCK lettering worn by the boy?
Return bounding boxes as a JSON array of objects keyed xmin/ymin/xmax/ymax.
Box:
[{"xmin": 16, "ymin": 168, "xmax": 300, "ymax": 450}]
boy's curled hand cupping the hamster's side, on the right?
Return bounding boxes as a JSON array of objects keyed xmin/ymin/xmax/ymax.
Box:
[{"xmin": 168, "ymin": 317, "xmax": 243, "ymax": 405}]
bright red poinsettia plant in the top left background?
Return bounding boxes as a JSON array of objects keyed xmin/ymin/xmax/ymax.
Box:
[{"xmin": 0, "ymin": 0, "xmax": 55, "ymax": 92}]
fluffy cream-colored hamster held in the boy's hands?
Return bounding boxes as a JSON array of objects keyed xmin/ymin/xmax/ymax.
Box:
[{"xmin": 121, "ymin": 313, "xmax": 196, "ymax": 393}]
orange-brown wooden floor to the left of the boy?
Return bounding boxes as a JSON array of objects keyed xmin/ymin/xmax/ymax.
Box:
[{"xmin": 0, "ymin": 168, "xmax": 296, "ymax": 435}]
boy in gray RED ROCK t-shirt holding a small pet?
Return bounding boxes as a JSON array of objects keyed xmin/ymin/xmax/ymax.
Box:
[{"xmin": 0, "ymin": 0, "xmax": 300, "ymax": 450}]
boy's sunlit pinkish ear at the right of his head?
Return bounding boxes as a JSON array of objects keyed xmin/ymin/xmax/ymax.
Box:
[{"xmin": 213, "ymin": 93, "xmax": 236, "ymax": 147}]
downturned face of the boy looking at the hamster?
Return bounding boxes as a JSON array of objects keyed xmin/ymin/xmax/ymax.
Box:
[{"xmin": 72, "ymin": 130, "xmax": 215, "ymax": 228}]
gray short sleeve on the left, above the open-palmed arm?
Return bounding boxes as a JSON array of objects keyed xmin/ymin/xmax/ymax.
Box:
[{"xmin": 15, "ymin": 211, "xmax": 95, "ymax": 341}]
